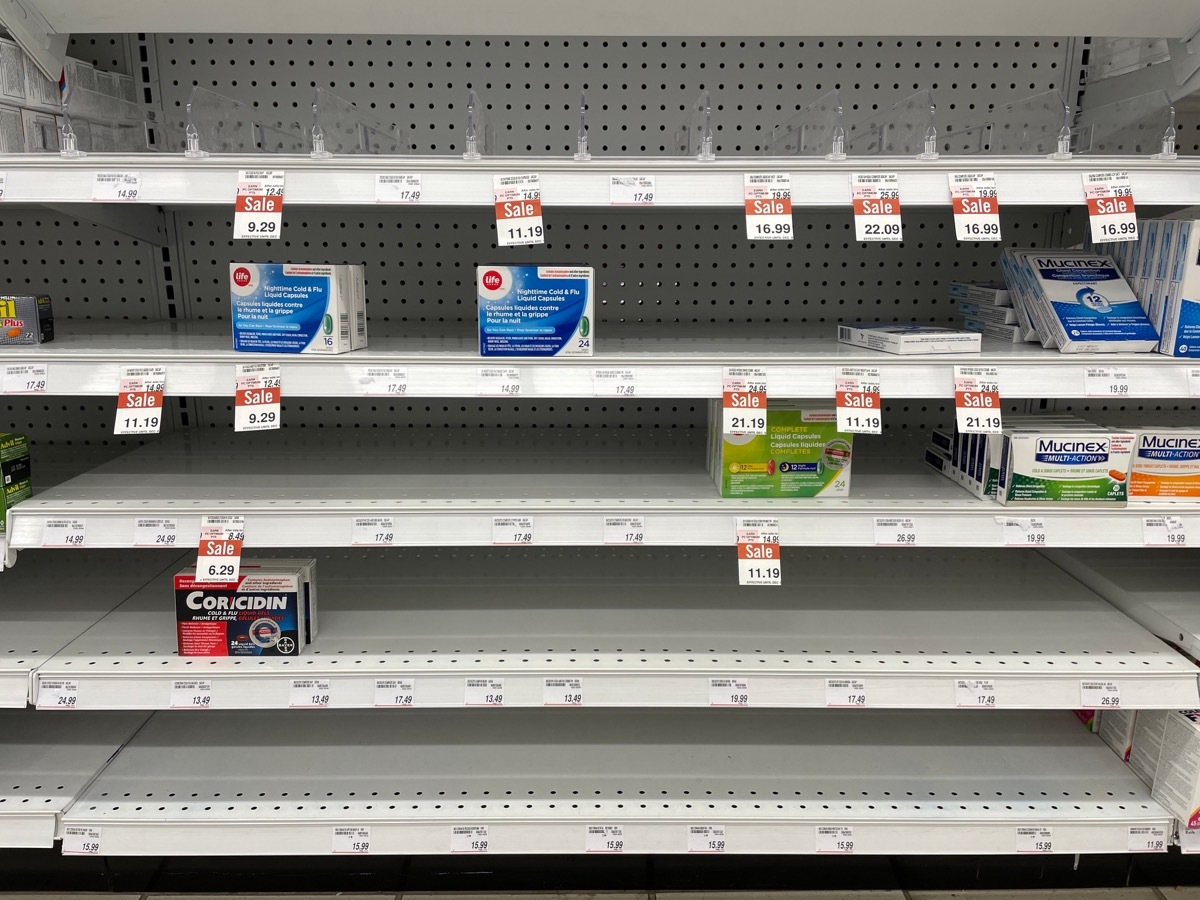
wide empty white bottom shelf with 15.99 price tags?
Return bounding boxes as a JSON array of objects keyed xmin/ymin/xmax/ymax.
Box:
[{"xmin": 64, "ymin": 710, "xmax": 1171, "ymax": 856}]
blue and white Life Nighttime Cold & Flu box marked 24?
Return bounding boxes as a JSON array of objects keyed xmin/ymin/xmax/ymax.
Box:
[{"xmin": 475, "ymin": 265, "xmax": 595, "ymax": 356}]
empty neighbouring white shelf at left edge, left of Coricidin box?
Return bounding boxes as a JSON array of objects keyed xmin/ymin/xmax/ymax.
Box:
[{"xmin": 0, "ymin": 551, "xmax": 186, "ymax": 708}]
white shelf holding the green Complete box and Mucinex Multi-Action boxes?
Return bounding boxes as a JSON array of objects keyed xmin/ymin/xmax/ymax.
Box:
[{"xmin": 8, "ymin": 428, "xmax": 1200, "ymax": 552}]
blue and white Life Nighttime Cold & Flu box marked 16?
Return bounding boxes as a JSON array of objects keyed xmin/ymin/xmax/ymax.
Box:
[{"xmin": 229, "ymin": 263, "xmax": 366, "ymax": 354}]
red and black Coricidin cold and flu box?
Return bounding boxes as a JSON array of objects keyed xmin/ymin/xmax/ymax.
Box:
[{"xmin": 175, "ymin": 564, "xmax": 305, "ymax": 656}]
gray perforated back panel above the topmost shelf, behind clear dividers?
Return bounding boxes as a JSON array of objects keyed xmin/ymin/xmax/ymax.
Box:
[{"xmin": 156, "ymin": 34, "xmax": 1073, "ymax": 156}]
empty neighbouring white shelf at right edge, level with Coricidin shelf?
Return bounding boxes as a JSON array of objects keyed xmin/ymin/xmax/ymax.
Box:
[{"xmin": 1049, "ymin": 548, "xmax": 1200, "ymax": 659}]
